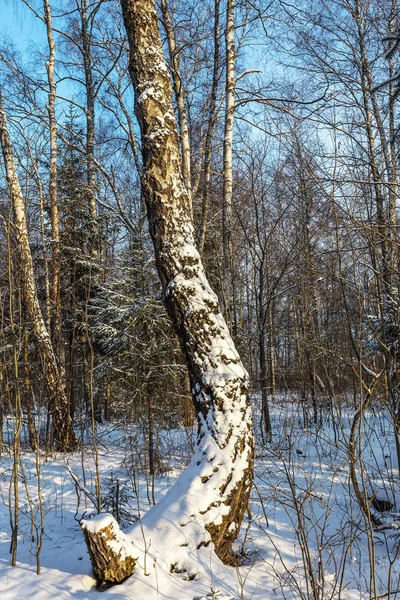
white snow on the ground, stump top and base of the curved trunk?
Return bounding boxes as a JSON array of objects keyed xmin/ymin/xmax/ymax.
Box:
[{"xmin": 0, "ymin": 398, "xmax": 400, "ymax": 600}]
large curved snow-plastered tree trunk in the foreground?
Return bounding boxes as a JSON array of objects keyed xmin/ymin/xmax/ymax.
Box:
[{"xmin": 83, "ymin": 0, "xmax": 253, "ymax": 576}]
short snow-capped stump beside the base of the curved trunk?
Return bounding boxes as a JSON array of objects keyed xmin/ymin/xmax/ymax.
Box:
[{"xmin": 81, "ymin": 513, "xmax": 137, "ymax": 587}]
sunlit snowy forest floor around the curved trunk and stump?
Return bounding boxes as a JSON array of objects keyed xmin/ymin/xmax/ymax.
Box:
[{"xmin": 0, "ymin": 399, "xmax": 400, "ymax": 600}]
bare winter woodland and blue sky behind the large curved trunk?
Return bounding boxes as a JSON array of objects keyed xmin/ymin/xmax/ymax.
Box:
[{"xmin": 0, "ymin": 0, "xmax": 400, "ymax": 596}]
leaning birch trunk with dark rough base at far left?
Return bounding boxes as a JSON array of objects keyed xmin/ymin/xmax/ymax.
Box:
[{"xmin": 0, "ymin": 96, "xmax": 77, "ymax": 451}]
